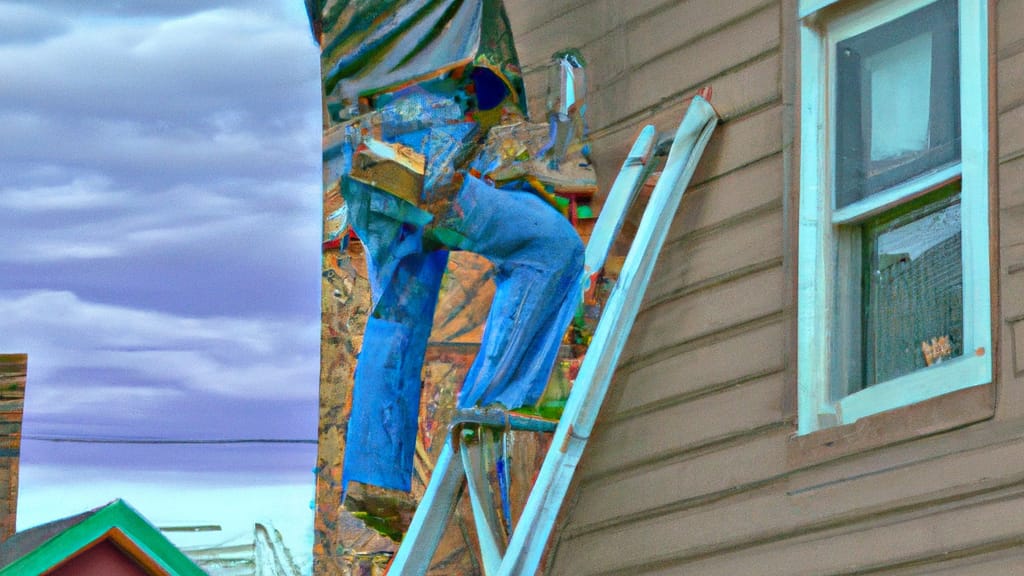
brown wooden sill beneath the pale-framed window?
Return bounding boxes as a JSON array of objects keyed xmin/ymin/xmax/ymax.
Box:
[{"xmin": 787, "ymin": 383, "xmax": 995, "ymax": 468}]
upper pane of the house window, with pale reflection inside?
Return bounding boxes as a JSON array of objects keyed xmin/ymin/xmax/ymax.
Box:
[{"xmin": 835, "ymin": 0, "xmax": 959, "ymax": 208}]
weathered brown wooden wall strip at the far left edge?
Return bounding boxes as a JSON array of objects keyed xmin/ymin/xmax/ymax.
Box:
[{"xmin": 0, "ymin": 354, "xmax": 29, "ymax": 541}]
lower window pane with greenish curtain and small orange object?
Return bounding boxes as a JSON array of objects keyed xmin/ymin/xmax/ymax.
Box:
[{"xmin": 863, "ymin": 195, "xmax": 964, "ymax": 385}]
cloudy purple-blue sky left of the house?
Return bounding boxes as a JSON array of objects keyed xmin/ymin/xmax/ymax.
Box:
[{"xmin": 0, "ymin": 0, "xmax": 321, "ymax": 565}]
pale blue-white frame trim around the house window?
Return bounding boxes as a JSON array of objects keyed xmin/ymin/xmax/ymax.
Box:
[{"xmin": 797, "ymin": 0, "xmax": 992, "ymax": 435}]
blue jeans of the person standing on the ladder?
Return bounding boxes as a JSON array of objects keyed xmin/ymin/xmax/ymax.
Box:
[{"xmin": 342, "ymin": 169, "xmax": 584, "ymax": 491}]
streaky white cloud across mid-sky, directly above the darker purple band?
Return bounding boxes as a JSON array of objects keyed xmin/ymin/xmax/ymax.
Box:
[{"xmin": 0, "ymin": 172, "xmax": 321, "ymax": 264}]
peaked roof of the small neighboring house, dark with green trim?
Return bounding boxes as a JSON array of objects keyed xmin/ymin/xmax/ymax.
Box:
[{"xmin": 0, "ymin": 500, "xmax": 205, "ymax": 576}]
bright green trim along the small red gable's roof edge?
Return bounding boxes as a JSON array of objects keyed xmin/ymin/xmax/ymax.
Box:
[{"xmin": 0, "ymin": 500, "xmax": 206, "ymax": 576}]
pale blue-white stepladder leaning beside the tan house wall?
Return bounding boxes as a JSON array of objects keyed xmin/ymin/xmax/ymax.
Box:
[{"xmin": 388, "ymin": 91, "xmax": 718, "ymax": 576}]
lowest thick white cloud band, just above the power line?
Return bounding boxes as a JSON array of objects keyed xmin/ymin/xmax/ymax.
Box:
[{"xmin": 0, "ymin": 291, "xmax": 319, "ymax": 401}]
